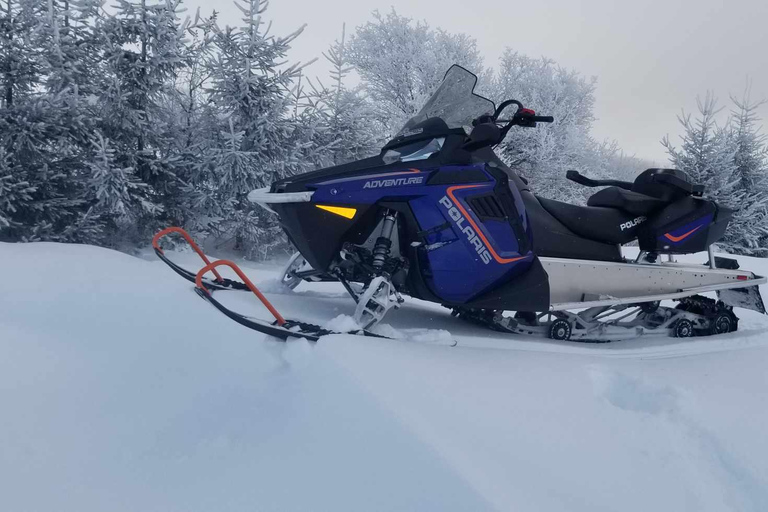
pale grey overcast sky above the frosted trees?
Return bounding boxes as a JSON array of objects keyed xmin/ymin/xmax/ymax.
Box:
[{"xmin": 185, "ymin": 0, "xmax": 768, "ymax": 163}]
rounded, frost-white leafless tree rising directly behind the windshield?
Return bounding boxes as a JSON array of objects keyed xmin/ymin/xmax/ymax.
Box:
[{"xmin": 347, "ymin": 9, "xmax": 483, "ymax": 136}]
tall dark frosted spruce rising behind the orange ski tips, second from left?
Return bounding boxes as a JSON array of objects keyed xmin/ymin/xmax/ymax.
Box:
[{"xmin": 97, "ymin": 0, "xmax": 186, "ymax": 233}]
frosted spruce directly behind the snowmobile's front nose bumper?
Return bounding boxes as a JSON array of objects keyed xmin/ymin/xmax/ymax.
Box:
[{"xmin": 187, "ymin": 0, "xmax": 306, "ymax": 256}]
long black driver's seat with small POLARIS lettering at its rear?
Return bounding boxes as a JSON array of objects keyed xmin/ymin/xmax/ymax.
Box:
[{"xmin": 538, "ymin": 197, "xmax": 643, "ymax": 244}]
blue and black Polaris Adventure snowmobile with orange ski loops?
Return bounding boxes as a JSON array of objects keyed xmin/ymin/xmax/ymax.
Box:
[{"xmin": 155, "ymin": 66, "xmax": 766, "ymax": 341}]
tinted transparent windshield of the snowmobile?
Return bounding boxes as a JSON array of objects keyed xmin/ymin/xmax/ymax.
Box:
[{"xmin": 397, "ymin": 64, "xmax": 496, "ymax": 137}]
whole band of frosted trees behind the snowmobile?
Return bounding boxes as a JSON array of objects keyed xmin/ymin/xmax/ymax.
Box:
[{"xmin": 0, "ymin": 0, "xmax": 768, "ymax": 259}]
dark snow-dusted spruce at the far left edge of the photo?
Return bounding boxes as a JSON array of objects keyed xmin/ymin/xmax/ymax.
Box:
[{"xmin": 0, "ymin": 0, "xmax": 99, "ymax": 241}]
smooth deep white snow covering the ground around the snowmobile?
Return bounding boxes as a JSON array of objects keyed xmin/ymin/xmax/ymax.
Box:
[{"xmin": 0, "ymin": 243, "xmax": 768, "ymax": 512}]
